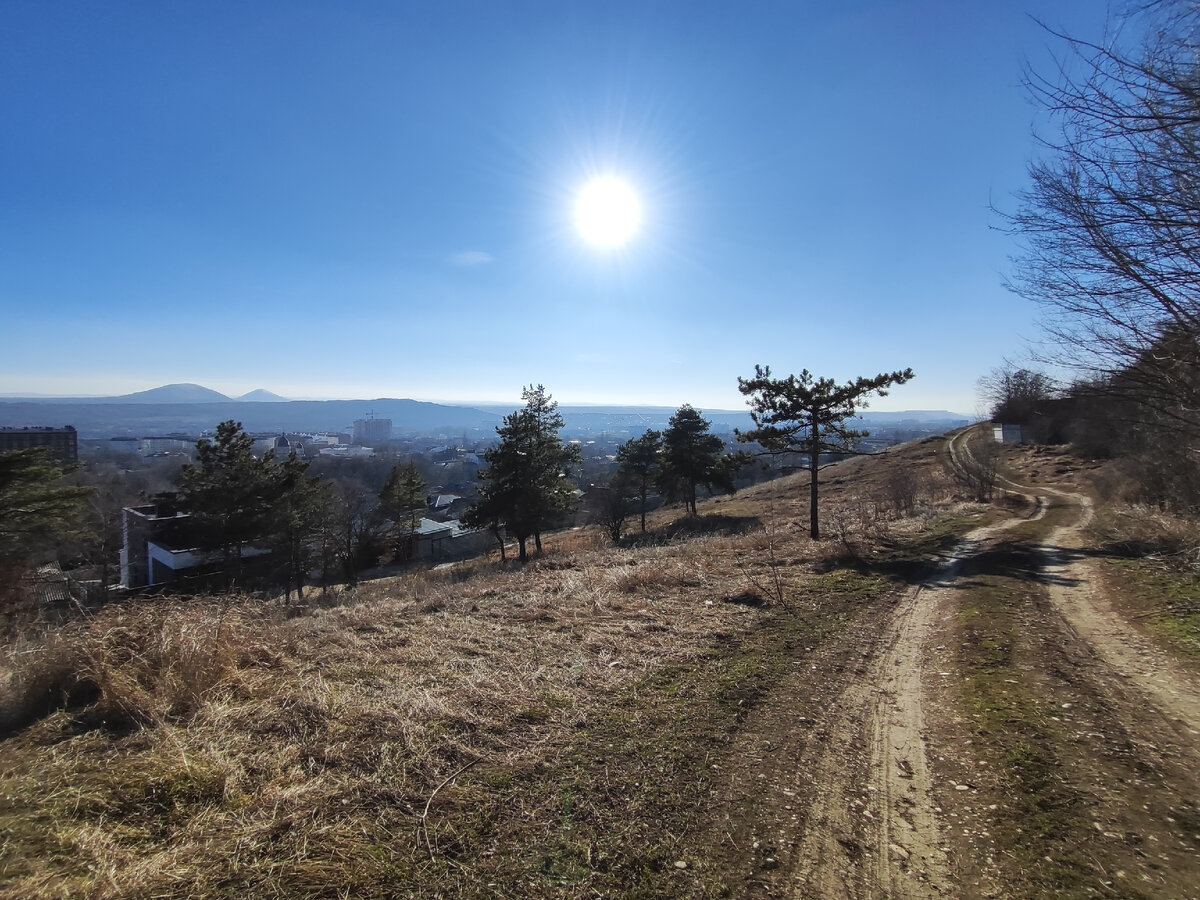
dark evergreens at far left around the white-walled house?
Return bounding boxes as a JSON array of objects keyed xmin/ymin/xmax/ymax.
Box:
[{"xmin": 0, "ymin": 421, "xmax": 426, "ymax": 606}]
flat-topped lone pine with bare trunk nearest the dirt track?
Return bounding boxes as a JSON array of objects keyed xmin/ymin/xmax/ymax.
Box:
[{"xmin": 738, "ymin": 366, "xmax": 913, "ymax": 540}]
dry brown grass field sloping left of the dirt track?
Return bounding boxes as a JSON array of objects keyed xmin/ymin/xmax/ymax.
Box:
[{"xmin": 0, "ymin": 439, "xmax": 1195, "ymax": 898}]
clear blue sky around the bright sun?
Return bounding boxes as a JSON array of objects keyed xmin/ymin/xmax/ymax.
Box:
[{"xmin": 0, "ymin": 0, "xmax": 1105, "ymax": 413}]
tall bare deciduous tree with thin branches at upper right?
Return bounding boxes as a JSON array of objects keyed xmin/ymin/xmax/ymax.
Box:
[{"xmin": 1007, "ymin": 0, "xmax": 1200, "ymax": 430}]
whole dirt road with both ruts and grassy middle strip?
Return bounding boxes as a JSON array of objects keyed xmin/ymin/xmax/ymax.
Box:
[{"xmin": 718, "ymin": 436, "xmax": 1200, "ymax": 898}]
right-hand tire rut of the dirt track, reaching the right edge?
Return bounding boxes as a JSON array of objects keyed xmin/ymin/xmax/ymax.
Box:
[{"xmin": 974, "ymin": 451, "xmax": 1200, "ymax": 898}]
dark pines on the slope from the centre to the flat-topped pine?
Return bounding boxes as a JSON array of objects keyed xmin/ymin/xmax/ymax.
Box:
[{"xmin": 464, "ymin": 366, "xmax": 913, "ymax": 562}]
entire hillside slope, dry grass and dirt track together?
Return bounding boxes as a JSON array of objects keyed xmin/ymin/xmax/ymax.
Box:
[{"xmin": 0, "ymin": 438, "xmax": 1200, "ymax": 898}]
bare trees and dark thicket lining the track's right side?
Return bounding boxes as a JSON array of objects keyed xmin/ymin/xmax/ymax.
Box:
[{"xmin": 983, "ymin": 0, "xmax": 1200, "ymax": 516}]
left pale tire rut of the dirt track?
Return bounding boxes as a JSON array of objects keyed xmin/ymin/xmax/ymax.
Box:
[{"xmin": 792, "ymin": 506, "xmax": 1045, "ymax": 898}]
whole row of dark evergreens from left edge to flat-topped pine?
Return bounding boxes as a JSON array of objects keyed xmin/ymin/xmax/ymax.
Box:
[{"xmin": 0, "ymin": 366, "xmax": 912, "ymax": 619}]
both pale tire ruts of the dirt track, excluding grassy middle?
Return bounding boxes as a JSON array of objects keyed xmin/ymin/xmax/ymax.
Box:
[{"xmin": 768, "ymin": 432, "xmax": 1200, "ymax": 898}]
